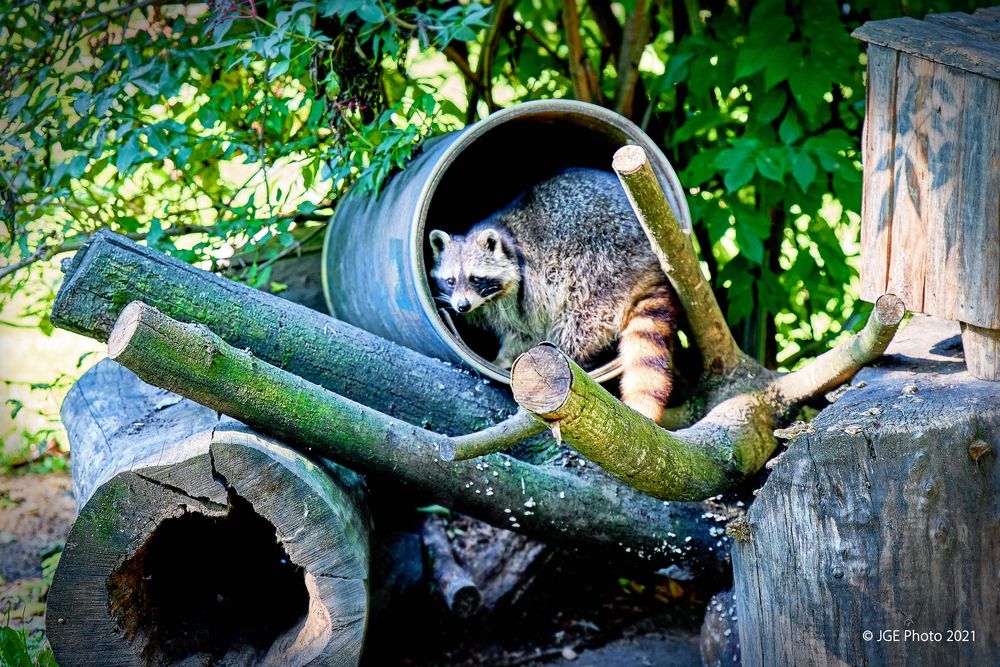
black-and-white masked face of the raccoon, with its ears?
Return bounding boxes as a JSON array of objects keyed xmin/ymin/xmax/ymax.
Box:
[{"xmin": 430, "ymin": 229, "xmax": 521, "ymax": 314}]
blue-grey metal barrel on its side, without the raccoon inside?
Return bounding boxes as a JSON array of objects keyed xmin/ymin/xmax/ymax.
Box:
[{"xmin": 323, "ymin": 100, "xmax": 691, "ymax": 384}]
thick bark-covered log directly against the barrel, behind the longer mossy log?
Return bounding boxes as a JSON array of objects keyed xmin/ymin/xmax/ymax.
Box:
[{"xmin": 51, "ymin": 231, "xmax": 516, "ymax": 435}]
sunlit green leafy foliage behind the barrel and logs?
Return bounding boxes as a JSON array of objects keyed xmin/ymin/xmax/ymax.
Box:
[{"xmin": 0, "ymin": 0, "xmax": 984, "ymax": 366}]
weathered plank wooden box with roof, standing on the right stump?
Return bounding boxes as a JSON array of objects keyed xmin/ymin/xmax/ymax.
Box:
[{"xmin": 854, "ymin": 7, "xmax": 1000, "ymax": 380}]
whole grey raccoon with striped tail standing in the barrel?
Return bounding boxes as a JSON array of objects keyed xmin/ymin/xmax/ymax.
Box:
[{"xmin": 429, "ymin": 169, "xmax": 677, "ymax": 421}]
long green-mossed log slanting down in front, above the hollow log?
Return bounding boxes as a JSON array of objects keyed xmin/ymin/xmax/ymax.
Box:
[{"xmin": 109, "ymin": 303, "xmax": 740, "ymax": 573}]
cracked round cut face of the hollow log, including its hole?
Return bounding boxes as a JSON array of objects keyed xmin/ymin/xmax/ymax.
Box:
[{"xmin": 47, "ymin": 432, "xmax": 368, "ymax": 665}]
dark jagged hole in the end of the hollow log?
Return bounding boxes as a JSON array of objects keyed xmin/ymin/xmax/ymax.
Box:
[{"xmin": 107, "ymin": 492, "xmax": 309, "ymax": 664}]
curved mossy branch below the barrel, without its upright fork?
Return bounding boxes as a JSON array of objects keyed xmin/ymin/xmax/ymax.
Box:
[{"xmin": 511, "ymin": 295, "xmax": 904, "ymax": 500}]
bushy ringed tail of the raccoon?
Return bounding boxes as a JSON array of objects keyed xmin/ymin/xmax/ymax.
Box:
[{"xmin": 618, "ymin": 281, "xmax": 677, "ymax": 422}]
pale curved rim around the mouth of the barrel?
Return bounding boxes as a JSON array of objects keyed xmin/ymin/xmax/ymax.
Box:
[{"xmin": 409, "ymin": 100, "xmax": 691, "ymax": 384}]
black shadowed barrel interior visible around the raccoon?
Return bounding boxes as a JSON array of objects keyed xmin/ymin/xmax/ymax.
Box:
[{"xmin": 419, "ymin": 111, "xmax": 634, "ymax": 376}]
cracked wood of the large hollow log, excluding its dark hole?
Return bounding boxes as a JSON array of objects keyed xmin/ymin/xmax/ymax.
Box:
[{"xmin": 46, "ymin": 361, "xmax": 370, "ymax": 665}]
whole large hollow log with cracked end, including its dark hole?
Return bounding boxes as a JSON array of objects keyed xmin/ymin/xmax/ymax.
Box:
[{"xmin": 46, "ymin": 361, "xmax": 370, "ymax": 666}]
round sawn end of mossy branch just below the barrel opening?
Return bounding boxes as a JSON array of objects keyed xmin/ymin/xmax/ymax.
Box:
[{"xmin": 510, "ymin": 344, "xmax": 573, "ymax": 416}]
